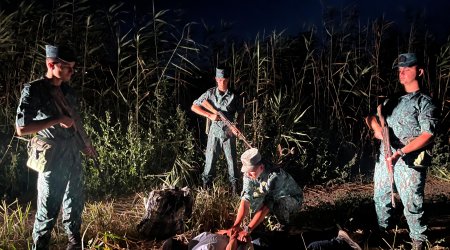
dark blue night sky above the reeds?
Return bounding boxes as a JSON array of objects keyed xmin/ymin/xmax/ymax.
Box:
[{"xmin": 153, "ymin": 0, "xmax": 450, "ymax": 42}]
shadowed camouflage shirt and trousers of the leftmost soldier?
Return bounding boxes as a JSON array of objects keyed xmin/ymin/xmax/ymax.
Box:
[{"xmin": 16, "ymin": 79, "xmax": 84, "ymax": 249}]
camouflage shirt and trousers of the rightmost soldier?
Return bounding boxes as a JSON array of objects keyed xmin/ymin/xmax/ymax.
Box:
[{"xmin": 374, "ymin": 91, "xmax": 437, "ymax": 241}]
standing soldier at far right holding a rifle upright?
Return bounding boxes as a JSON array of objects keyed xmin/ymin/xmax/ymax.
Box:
[{"xmin": 366, "ymin": 53, "xmax": 438, "ymax": 249}]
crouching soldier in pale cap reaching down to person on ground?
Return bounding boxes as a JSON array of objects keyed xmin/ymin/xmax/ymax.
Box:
[{"xmin": 221, "ymin": 148, "xmax": 303, "ymax": 242}]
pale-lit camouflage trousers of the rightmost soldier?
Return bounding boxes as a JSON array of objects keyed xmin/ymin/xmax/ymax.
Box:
[{"xmin": 373, "ymin": 155, "xmax": 427, "ymax": 241}]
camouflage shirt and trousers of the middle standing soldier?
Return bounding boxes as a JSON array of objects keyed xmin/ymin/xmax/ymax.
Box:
[{"xmin": 194, "ymin": 87, "xmax": 244, "ymax": 185}]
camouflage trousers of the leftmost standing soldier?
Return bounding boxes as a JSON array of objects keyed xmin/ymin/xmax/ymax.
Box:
[{"xmin": 32, "ymin": 142, "xmax": 84, "ymax": 249}]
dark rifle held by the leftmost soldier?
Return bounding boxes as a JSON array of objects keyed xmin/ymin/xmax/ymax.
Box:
[{"xmin": 50, "ymin": 87, "xmax": 99, "ymax": 166}]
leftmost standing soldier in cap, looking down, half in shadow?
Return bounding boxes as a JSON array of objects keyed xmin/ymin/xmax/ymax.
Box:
[{"xmin": 16, "ymin": 45, "xmax": 94, "ymax": 249}]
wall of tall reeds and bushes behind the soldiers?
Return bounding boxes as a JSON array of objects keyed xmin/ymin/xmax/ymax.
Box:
[{"xmin": 0, "ymin": 0, "xmax": 450, "ymax": 197}]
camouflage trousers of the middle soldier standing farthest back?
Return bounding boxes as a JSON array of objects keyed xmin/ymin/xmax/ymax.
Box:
[{"xmin": 202, "ymin": 135, "xmax": 237, "ymax": 185}]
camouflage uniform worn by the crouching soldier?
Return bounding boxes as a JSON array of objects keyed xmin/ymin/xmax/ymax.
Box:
[{"xmin": 241, "ymin": 163, "xmax": 303, "ymax": 224}]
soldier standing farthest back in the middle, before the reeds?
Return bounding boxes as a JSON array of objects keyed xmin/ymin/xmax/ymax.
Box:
[{"xmin": 191, "ymin": 67, "xmax": 244, "ymax": 193}]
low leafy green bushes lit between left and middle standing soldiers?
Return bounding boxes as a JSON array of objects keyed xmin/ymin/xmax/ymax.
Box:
[{"xmin": 85, "ymin": 105, "xmax": 200, "ymax": 195}]
